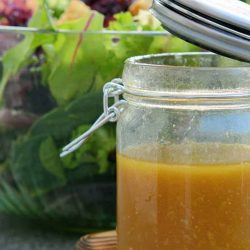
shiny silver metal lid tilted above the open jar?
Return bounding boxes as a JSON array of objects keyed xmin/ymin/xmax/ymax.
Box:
[{"xmin": 152, "ymin": 0, "xmax": 250, "ymax": 62}]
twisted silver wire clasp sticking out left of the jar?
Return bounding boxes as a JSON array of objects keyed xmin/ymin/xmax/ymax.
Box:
[{"xmin": 60, "ymin": 78, "xmax": 126, "ymax": 157}]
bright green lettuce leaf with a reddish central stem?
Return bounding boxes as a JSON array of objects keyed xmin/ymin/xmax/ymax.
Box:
[{"xmin": 47, "ymin": 12, "xmax": 106, "ymax": 104}]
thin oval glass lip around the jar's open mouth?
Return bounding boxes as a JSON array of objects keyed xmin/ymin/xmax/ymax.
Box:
[{"xmin": 125, "ymin": 52, "xmax": 250, "ymax": 71}]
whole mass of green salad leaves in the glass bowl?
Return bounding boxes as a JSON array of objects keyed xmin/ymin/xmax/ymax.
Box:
[{"xmin": 0, "ymin": 1, "xmax": 197, "ymax": 229}]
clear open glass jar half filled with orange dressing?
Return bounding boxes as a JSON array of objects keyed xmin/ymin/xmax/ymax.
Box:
[{"xmin": 117, "ymin": 53, "xmax": 250, "ymax": 250}]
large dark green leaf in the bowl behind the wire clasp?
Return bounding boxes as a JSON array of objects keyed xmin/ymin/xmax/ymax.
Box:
[{"xmin": 10, "ymin": 92, "xmax": 105, "ymax": 195}]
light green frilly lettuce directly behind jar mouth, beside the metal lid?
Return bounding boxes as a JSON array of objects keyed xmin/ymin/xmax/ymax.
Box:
[{"xmin": 106, "ymin": 12, "xmax": 199, "ymax": 60}]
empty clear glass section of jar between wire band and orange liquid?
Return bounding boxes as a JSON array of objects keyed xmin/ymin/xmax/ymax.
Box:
[{"xmin": 117, "ymin": 102, "xmax": 250, "ymax": 153}]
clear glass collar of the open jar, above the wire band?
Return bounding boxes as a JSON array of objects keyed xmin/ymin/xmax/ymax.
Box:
[{"xmin": 123, "ymin": 52, "xmax": 250, "ymax": 106}]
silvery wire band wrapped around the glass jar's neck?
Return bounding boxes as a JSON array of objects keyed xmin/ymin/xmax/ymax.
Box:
[{"xmin": 123, "ymin": 90, "xmax": 250, "ymax": 110}]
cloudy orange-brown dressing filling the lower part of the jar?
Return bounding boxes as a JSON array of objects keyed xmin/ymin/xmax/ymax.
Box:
[{"xmin": 117, "ymin": 144, "xmax": 250, "ymax": 250}]
